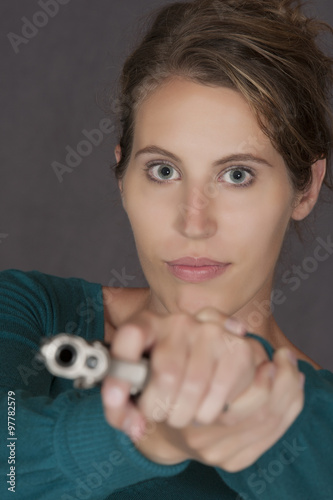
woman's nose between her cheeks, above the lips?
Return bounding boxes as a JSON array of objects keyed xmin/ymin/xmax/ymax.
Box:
[{"xmin": 176, "ymin": 188, "xmax": 217, "ymax": 239}]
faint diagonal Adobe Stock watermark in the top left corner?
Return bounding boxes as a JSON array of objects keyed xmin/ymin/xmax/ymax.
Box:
[{"xmin": 7, "ymin": 0, "xmax": 70, "ymax": 54}]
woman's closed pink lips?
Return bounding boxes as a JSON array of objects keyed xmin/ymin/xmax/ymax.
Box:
[{"xmin": 166, "ymin": 257, "xmax": 230, "ymax": 283}]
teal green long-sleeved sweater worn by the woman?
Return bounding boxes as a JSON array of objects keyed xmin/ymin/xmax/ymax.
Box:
[{"xmin": 0, "ymin": 270, "xmax": 333, "ymax": 500}]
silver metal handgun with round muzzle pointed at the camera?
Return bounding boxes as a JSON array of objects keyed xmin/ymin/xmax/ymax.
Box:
[{"xmin": 36, "ymin": 333, "xmax": 149, "ymax": 396}]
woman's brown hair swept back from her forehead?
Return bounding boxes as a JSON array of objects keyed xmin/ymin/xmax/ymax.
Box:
[{"xmin": 112, "ymin": 0, "xmax": 333, "ymax": 195}]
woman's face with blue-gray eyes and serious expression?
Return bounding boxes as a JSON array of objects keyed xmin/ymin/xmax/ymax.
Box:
[{"xmin": 117, "ymin": 79, "xmax": 294, "ymax": 317}]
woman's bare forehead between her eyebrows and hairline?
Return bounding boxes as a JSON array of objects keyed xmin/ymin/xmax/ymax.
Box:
[{"xmin": 133, "ymin": 78, "xmax": 278, "ymax": 160}]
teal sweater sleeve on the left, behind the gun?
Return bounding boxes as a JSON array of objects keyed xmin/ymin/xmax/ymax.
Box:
[{"xmin": 0, "ymin": 270, "xmax": 190, "ymax": 500}]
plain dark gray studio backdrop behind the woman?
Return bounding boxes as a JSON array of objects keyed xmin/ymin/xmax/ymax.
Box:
[{"xmin": 0, "ymin": 0, "xmax": 333, "ymax": 370}]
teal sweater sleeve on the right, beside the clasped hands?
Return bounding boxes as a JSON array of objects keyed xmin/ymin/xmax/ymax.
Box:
[{"xmin": 215, "ymin": 334, "xmax": 333, "ymax": 500}]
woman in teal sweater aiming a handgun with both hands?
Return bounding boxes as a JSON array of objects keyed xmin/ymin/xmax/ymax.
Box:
[{"xmin": 1, "ymin": 0, "xmax": 333, "ymax": 500}]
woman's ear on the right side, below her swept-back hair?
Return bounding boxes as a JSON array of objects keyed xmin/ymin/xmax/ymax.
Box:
[{"xmin": 291, "ymin": 159, "xmax": 326, "ymax": 220}]
